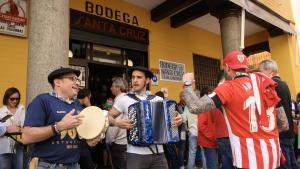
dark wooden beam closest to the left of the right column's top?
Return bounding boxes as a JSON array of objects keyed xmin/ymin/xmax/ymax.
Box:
[{"xmin": 170, "ymin": 1, "xmax": 209, "ymax": 28}]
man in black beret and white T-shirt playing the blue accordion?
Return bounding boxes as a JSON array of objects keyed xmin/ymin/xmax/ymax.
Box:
[{"xmin": 109, "ymin": 66, "xmax": 182, "ymax": 169}]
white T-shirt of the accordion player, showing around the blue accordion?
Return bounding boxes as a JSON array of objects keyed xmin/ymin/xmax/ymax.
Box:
[{"xmin": 113, "ymin": 95, "xmax": 164, "ymax": 155}]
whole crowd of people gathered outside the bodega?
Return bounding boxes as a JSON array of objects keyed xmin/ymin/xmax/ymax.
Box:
[{"xmin": 0, "ymin": 51, "xmax": 300, "ymax": 169}]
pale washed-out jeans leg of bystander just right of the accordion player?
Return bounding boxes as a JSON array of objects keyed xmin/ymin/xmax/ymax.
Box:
[{"xmin": 187, "ymin": 134, "xmax": 198, "ymax": 169}]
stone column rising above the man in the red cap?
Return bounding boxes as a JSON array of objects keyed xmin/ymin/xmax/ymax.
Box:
[{"xmin": 219, "ymin": 5, "xmax": 241, "ymax": 57}]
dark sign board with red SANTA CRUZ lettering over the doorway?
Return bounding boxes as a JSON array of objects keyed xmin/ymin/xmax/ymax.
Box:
[{"xmin": 70, "ymin": 9, "xmax": 149, "ymax": 44}]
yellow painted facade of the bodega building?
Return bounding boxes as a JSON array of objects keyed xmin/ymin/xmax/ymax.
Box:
[{"xmin": 0, "ymin": 0, "xmax": 300, "ymax": 104}]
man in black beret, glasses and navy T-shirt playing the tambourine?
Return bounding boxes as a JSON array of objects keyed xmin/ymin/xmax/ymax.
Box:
[{"xmin": 22, "ymin": 68, "xmax": 99, "ymax": 169}]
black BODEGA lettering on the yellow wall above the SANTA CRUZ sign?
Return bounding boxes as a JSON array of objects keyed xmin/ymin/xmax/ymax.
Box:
[{"xmin": 85, "ymin": 1, "xmax": 139, "ymax": 26}]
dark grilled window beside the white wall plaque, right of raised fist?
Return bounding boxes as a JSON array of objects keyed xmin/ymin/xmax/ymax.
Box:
[{"xmin": 193, "ymin": 54, "xmax": 220, "ymax": 90}]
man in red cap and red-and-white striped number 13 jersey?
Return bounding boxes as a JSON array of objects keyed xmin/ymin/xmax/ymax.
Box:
[{"xmin": 183, "ymin": 51, "xmax": 289, "ymax": 169}]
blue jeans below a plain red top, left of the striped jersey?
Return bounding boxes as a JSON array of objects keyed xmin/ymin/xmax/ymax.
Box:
[{"xmin": 201, "ymin": 147, "xmax": 218, "ymax": 169}]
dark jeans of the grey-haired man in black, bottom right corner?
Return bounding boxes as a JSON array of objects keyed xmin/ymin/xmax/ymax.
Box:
[{"xmin": 279, "ymin": 138, "xmax": 300, "ymax": 169}]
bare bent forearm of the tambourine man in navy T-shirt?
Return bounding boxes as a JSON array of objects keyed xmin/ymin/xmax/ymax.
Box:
[{"xmin": 22, "ymin": 126, "xmax": 55, "ymax": 144}]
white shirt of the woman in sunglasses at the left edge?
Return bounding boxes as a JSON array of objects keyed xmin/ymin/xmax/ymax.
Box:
[{"xmin": 0, "ymin": 104, "xmax": 25, "ymax": 154}]
